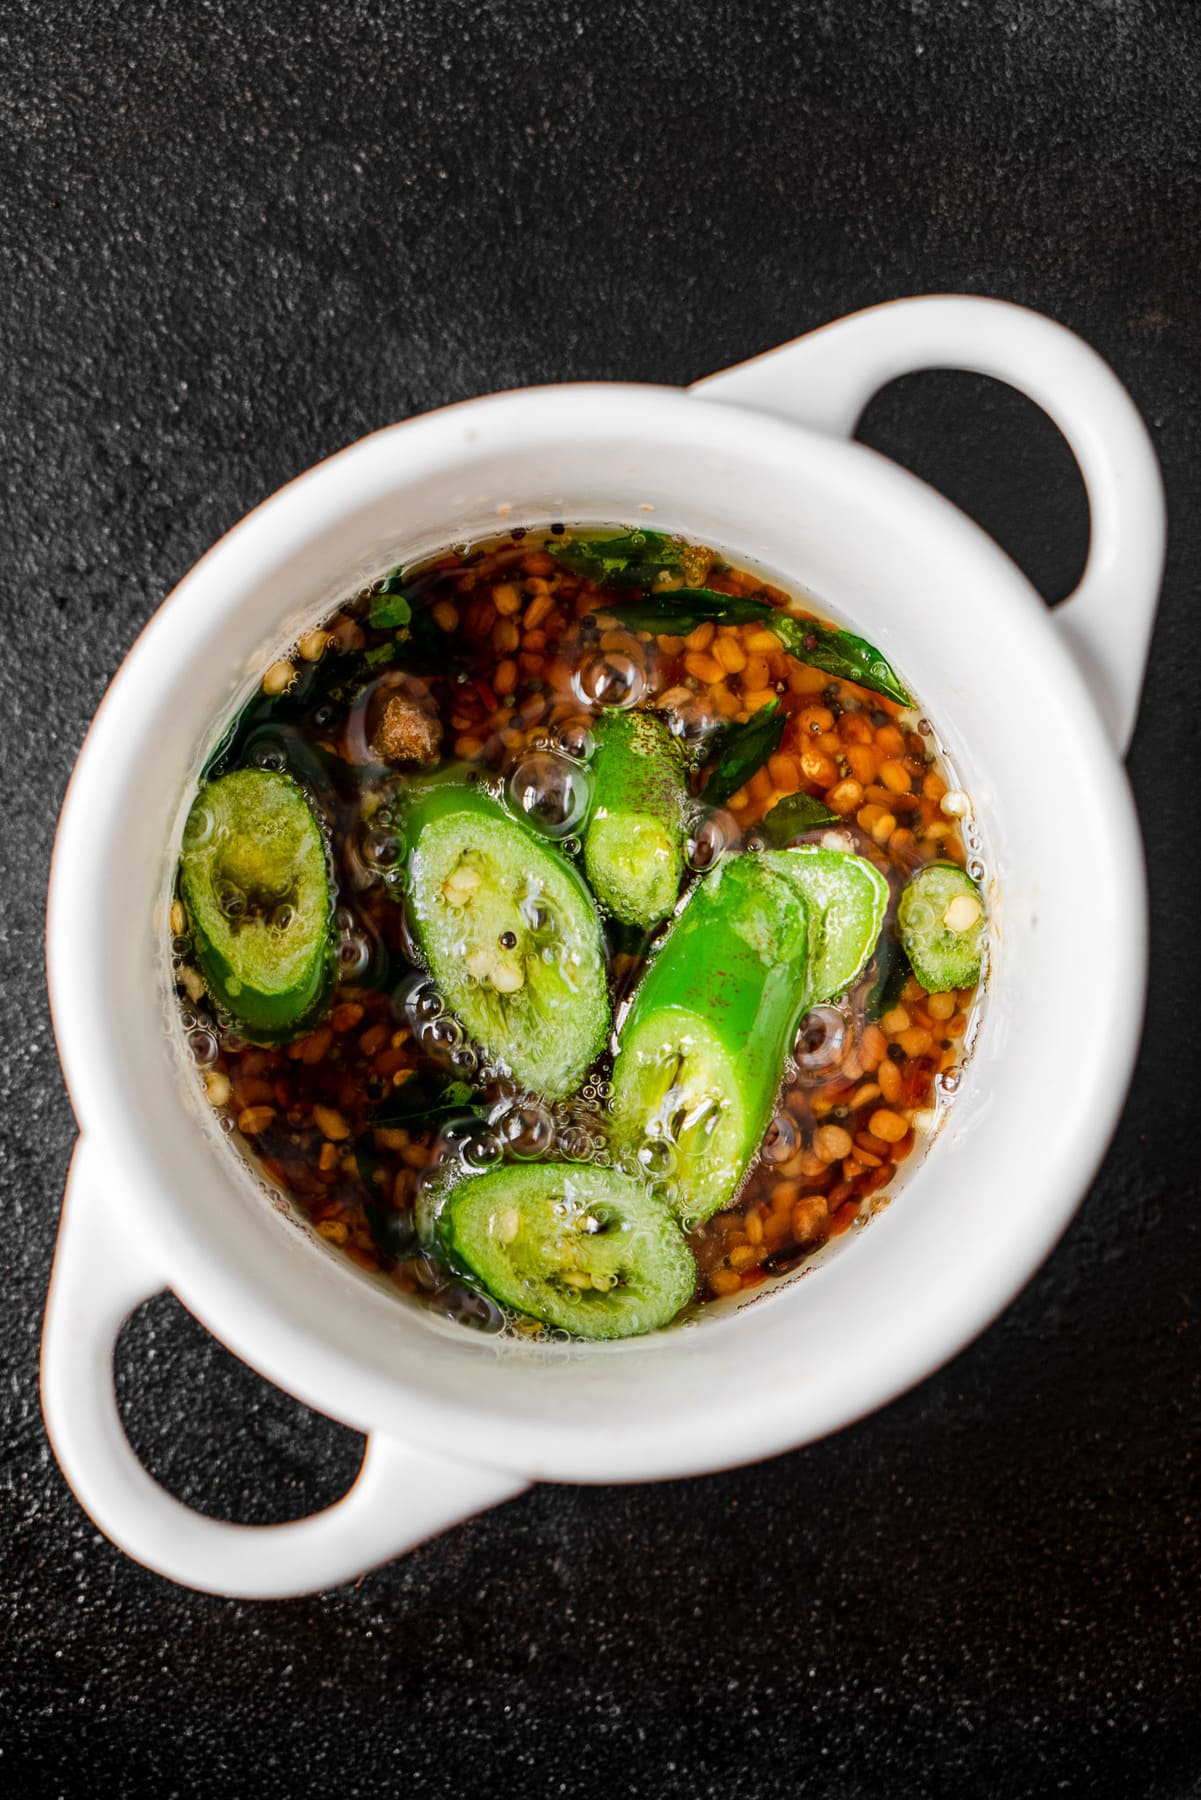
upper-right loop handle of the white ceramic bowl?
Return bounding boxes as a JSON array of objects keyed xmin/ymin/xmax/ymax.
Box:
[{"xmin": 691, "ymin": 293, "xmax": 1165, "ymax": 754}]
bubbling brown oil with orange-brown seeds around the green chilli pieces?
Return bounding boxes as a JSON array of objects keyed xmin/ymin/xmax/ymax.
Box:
[{"xmin": 171, "ymin": 526, "xmax": 980, "ymax": 1332}]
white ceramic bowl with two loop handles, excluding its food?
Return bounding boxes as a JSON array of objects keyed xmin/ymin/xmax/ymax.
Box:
[{"xmin": 41, "ymin": 297, "xmax": 1163, "ymax": 1595}]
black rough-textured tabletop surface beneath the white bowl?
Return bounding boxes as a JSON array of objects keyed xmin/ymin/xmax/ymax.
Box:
[{"xmin": 0, "ymin": 0, "xmax": 1201, "ymax": 1800}]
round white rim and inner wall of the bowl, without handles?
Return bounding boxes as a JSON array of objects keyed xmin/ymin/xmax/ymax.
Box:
[{"xmin": 50, "ymin": 387, "xmax": 1145, "ymax": 1480}]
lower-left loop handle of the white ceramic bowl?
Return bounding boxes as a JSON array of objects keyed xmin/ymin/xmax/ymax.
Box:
[{"xmin": 41, "ymin": 1139, "xmax": 528, "ymax": 1600}]
